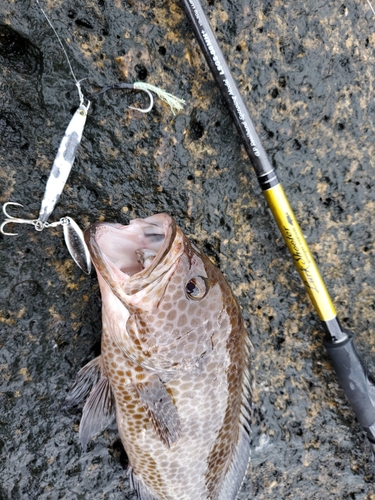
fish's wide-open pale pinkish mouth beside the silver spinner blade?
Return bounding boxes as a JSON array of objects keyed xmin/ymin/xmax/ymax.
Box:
[{"xmin": 85, "ymin": 214, "xmax": 176, "ymax": 283}]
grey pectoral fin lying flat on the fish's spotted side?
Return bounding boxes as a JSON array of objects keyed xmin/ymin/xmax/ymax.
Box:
[{"xmin": 135, "ymin": 375, "xmax": 181, "ymax": 448}]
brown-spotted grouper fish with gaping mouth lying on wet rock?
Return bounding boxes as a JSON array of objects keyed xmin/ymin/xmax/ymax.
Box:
[{"xmin": 67, "ymin": 214, "xmax": 251, "ymax": 500}]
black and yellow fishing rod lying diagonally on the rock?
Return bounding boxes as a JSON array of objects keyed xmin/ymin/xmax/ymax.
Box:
[{"xmin": 181, "ymin": 0, "xmax": 375, "ymax": 453}]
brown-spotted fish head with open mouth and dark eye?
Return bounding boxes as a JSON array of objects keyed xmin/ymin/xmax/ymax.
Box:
[{"xmin": 85, "ymin": 214, "xmax": 238, "ymax": 372}]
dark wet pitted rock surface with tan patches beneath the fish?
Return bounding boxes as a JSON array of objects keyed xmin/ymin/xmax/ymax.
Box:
[{"xmin": 0, "ymin": 0, "xmax": 375, "ymax": 500}]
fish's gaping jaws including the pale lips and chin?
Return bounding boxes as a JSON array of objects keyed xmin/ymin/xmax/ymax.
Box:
[{"xmin": 85, "ymin": 214, "xmax": 183, "ymax": 307}]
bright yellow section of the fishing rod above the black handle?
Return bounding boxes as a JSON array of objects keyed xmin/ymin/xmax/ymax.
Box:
[{"xmin": 263, "ymin": 184, "xmax": 336, "ymax": 321}]
